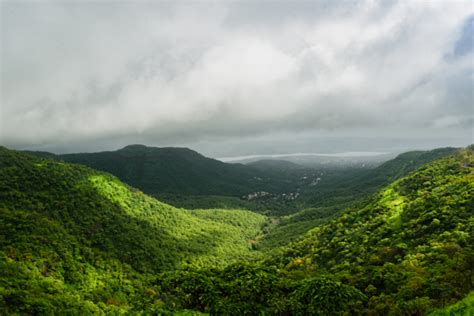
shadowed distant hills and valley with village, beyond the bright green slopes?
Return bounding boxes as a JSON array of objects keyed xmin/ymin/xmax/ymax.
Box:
[{"xmin": 25, "ymin": 145, "xmax": 456, "ymax": 216}]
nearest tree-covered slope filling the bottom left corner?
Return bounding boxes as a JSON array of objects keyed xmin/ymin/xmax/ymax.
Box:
[{"xmin": 0, "ymin": 209, "xmax": 151, "ymax": 314}]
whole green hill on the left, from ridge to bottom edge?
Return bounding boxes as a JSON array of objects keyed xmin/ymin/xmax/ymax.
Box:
[{"xmin": 0, "ymin": 147, "xmax": 266, "ymax": 313}]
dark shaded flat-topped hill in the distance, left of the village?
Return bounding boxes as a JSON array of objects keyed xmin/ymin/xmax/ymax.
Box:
[{"xmin": 59, "ymin": 145, "xmax": 300, "ymax": 197}]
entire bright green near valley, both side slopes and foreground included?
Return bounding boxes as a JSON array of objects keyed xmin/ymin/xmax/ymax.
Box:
[{"xmin": 0, "ymin": 146, "xmax": 474, "ymax": 315}]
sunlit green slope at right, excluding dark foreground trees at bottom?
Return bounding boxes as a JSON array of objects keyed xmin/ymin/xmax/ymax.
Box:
[{"xmin": 278, "ymin": 146, "xmax": 474, "ymax": 314}]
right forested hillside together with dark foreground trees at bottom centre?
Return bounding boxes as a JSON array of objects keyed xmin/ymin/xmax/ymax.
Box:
[{"xmin": 150, "ymin": 146, "xmax": 474, "ymax": 315}]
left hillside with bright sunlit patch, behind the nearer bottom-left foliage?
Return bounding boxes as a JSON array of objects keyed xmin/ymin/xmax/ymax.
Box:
[{"xmin": 0, "ymin": 149, "xmax": 265, "ymax": 271}]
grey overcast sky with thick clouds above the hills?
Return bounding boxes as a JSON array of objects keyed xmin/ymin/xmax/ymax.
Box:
[{"xmin": 0, "ymin": 0, "xmax": 474, "ymax": 156}]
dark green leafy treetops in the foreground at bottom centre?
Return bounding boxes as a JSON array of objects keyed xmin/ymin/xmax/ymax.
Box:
[{"xmin": 156, "ymin": 263, "xmax": 365, "ymax": 315}]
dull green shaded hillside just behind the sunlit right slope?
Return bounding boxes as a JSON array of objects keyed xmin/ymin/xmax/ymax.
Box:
[{"xmin": 254, "ymin": 148, "xmax": 462, "ymax": 249}]
